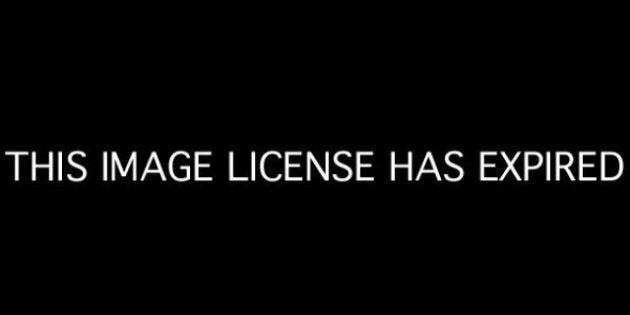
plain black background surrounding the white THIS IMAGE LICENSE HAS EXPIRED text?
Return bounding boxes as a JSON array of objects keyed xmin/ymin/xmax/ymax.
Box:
[{"xmin": 0, "ymin": 4, "xmax": 628, "ymax": 308}]
